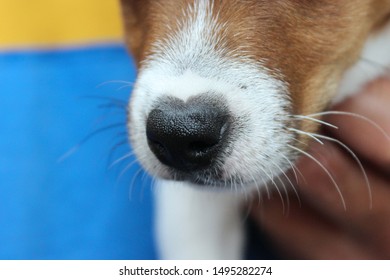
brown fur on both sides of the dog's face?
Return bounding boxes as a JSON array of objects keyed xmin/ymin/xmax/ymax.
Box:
[{"xmin": 121, "ymin": 0, "xmax": 390, "ymax": 140}]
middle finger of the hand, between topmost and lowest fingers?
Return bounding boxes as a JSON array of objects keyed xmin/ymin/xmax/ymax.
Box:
[{"xmin": 297, "ymin": 140, "xmax": 390, "ymax": 256}]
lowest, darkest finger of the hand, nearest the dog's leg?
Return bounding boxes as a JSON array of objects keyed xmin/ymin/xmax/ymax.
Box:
[{"xmin": 253, "ymin": 195, "xmax": 373, "ymax": 259}]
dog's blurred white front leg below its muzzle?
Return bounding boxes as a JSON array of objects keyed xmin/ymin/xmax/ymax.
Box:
[{"xmin": 156, "ymin": 181, "xmax": 244, "ymax": 259}]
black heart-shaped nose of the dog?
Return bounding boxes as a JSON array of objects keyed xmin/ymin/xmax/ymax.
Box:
[{"xmin": 146, "ymin": 99, "xmax": 229, "ymax": 172}]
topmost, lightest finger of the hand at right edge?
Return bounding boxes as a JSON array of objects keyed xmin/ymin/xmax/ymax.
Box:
[{"xmin": 326, "ymin": 78, "xmax": 390, "ymax": 172}]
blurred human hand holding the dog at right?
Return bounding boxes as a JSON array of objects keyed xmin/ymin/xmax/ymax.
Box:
[{"xmin": 252, "ymin": 78, "xmax": 390, "ymax": 259}]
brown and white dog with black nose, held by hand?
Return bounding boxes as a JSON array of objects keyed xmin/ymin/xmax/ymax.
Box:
[{"xmin": 121, "ymin": 0, "xmax": 390, "ymax": 259}]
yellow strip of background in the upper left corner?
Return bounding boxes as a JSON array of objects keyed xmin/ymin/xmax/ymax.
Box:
[{"xmin": 0, "ymin": 0, "xmax": 122, "ymax": 49}]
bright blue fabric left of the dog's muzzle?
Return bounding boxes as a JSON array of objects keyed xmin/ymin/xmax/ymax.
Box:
[{"xmin": 0, "ymin": 45, "xmax": 156, "ymax": 259}]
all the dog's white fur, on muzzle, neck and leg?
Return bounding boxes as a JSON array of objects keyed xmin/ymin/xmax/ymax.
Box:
[{"xmin": 129, "ymin": 0, "xmax": 390, "ymax": 259}]
